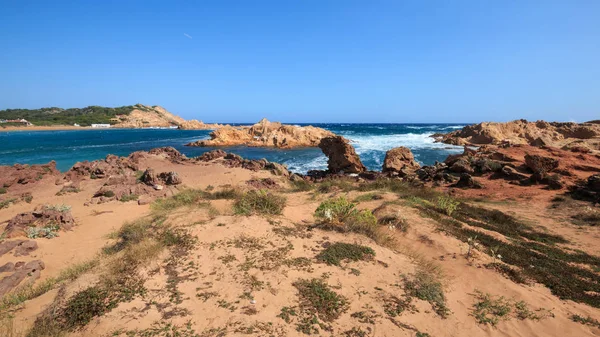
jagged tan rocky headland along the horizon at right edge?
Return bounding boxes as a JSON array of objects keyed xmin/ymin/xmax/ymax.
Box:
[{"xmin": 435, "ymin": 119, "xmax": 600, "ymax": 150}]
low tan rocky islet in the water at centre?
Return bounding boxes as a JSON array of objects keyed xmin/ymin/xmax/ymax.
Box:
[{"xmin": 187, "ymin": 119, "xmax": 334, "ymax": 148}]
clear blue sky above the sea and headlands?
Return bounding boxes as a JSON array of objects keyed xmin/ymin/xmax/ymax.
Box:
[{"xmin": 0, "ymin": 0, "xmax": 600, "ymax": 123}]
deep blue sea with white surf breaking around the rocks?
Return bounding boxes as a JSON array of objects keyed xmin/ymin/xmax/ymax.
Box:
[{"xmin": 0, "ymin": 123, "xmax": 467, "ymax": 173}]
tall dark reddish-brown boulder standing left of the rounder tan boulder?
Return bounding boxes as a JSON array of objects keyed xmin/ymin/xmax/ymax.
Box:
[{"xmin": 319, "ymin": 136, "xmax": 366, "ymax": 173}]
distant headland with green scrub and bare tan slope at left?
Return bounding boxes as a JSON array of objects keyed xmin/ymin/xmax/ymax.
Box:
[{"xmin": 0, "ymin": 104, "xmax": 219, "ymax": 129}]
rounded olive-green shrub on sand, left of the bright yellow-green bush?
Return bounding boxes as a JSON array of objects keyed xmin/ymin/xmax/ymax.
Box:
[{"xmin": 233, "ymin": 190, "xmax": 286, "ymax": 215}]
